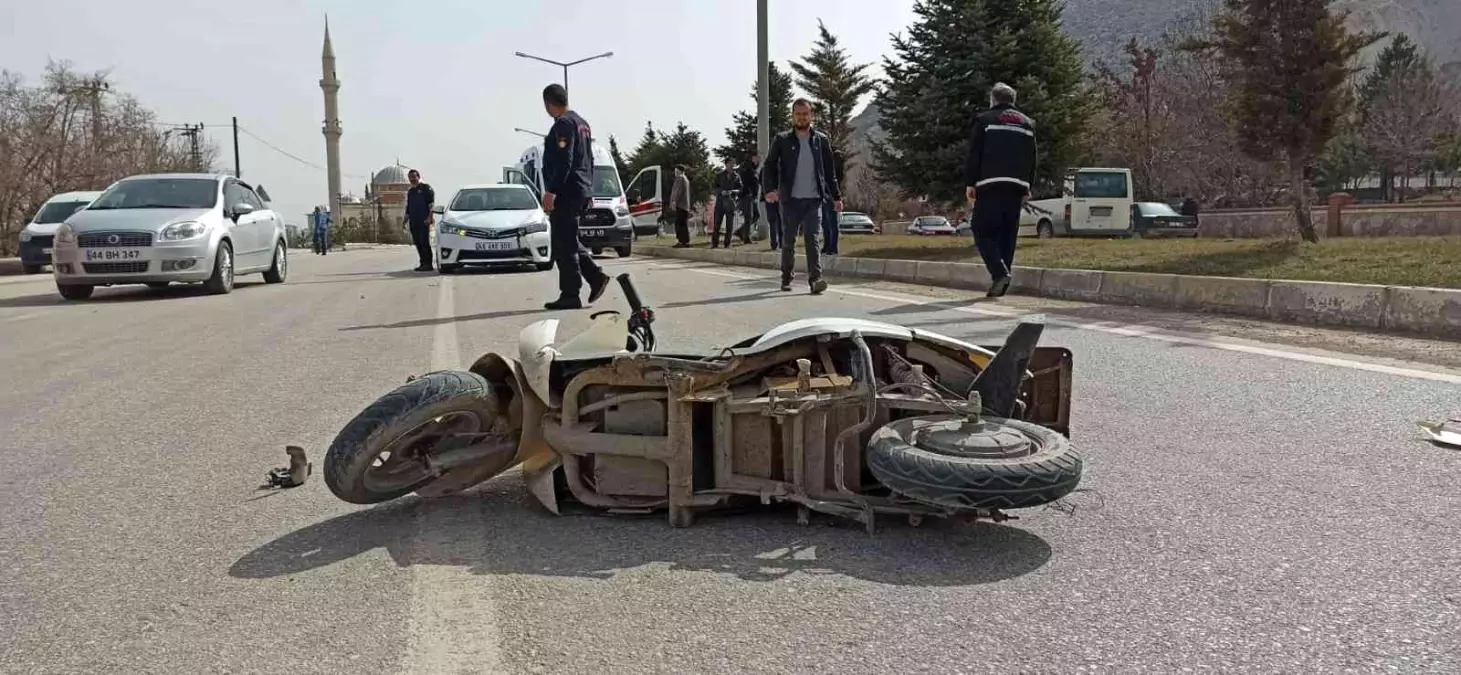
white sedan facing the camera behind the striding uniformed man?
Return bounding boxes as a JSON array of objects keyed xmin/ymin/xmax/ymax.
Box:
[{"xmin": 435, "ymin": 183, "xmax": 552, "ymax": 275}]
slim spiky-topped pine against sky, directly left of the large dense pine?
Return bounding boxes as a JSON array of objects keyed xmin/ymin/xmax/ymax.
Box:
[{"xmin": 790, "ymin": 19, "xmax": 877, "ymax": 167}]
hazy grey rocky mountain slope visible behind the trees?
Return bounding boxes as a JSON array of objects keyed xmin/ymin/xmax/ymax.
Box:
[{"xmin": 852, "ymin": 0, "xmax": 1461, "ymax": 146}]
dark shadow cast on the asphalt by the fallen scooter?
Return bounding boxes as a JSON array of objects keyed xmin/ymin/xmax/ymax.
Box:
[{"xmin": 228, "ymin": 492, "xmax": 1050, "ymax": 586}]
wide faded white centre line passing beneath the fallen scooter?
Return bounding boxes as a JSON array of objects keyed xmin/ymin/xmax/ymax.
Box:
[{"xmin": 402, "ymin": 276, "xmax": 506, "ymax": 675}]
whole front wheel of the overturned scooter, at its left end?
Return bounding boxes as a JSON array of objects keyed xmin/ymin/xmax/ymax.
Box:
[{"xmin": 323, "ymin": 371, "xmax": 503, "ymax": 504}]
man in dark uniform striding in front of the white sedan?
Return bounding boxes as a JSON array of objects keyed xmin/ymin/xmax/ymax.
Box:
[{"xmin": 542, "ymin": 85, "xmax": 609, "ymax": 310}]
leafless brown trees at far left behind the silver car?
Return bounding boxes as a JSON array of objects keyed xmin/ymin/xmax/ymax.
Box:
[{"xmin": 0, "ymin": 61, "xmax": 218, "ymax": 256}]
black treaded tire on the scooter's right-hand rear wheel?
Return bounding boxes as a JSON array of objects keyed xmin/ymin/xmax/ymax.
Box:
[{"xmin": 868, "ymin": 418, "xmax": 1084, "ymax": 510}]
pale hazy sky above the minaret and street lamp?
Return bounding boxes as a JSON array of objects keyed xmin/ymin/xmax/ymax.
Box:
[{"xmin": 0, "ymin": 0, "xmax": 913, "ymax": 224}]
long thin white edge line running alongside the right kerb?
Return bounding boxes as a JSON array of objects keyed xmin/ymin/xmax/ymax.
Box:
[{"xmin": 666, "ymin": 264, "xmax": 1461, "ymax": 384}]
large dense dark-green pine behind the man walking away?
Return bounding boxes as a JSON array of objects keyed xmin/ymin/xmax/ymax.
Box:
[{"xmin": 872, "ymin": 0, "xmax": 1091, "ymax": 203}]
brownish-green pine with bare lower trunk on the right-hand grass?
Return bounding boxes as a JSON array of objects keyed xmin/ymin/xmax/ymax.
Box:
[{"xmin": 1192, "ymin": 0, "xmax": 1378, "ymax": 243}]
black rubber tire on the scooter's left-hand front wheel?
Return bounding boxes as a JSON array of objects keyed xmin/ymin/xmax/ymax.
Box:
[{"xmin": 323, "ymin": 370, "xmax": 498, "ymax": 504}]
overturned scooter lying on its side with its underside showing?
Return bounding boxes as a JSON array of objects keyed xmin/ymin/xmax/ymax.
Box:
[{"xmin": 324, "ymin": 275, "xmax": 1083, "ymax": 532}]
